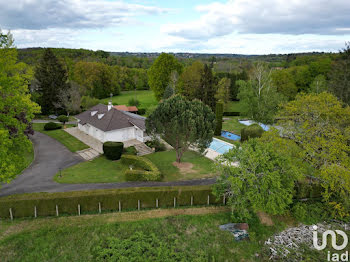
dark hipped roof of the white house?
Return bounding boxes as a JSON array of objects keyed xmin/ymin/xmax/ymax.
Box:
[{"xmin": 75, "ymin": 104, "xmax": 146, "ymax": 132}]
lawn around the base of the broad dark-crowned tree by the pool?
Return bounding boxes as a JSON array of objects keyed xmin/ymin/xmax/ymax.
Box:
[{"xmin": 144, "ymin": 150, "xmax": 215, "ymax": 181}]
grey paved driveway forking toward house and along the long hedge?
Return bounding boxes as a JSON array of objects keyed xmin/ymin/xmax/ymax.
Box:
[{"xmin": 0, "ymin": 132, "xmax": 215, "ymax": 196}]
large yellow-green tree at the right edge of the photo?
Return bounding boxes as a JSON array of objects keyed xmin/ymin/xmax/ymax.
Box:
[{"xmin": 278, "ymin": 92, "xmax": 350, "ymax": 216}]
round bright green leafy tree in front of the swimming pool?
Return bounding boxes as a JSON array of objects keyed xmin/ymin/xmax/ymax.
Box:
[{"xmin": 214, "ymin": 139, "xmax": 301, "ymax": 220}]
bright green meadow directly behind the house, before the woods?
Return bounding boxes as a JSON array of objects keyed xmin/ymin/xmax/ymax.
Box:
[{"xmin": 101, "ymin": 90, "xmax": 158, "ymax": 109}]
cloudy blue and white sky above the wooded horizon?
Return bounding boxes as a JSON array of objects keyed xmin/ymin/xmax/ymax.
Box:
[{"xmin": 0, "ymin": 0, "xmax": 350, "ymax": 54}]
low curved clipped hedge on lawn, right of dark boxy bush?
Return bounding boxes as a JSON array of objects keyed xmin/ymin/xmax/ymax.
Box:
[{"xmin": 121, "ymin": 155, "xmax": 162, "ymax": 181}]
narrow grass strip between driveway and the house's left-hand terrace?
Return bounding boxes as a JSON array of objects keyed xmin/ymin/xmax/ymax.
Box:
[{"xmin": 33, "ymin": 123, "xmax": 89, "ymax": 152}]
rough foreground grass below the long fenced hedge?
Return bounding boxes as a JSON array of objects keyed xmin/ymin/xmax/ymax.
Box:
[{"xmin": 0, "ymin": 209, "xmax": 292, "ymax": 261}]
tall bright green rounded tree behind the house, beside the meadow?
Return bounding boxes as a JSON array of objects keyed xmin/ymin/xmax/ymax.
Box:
[{"xmin": 148, "ymin": 53, "xmax": 182, "ymax": 101}]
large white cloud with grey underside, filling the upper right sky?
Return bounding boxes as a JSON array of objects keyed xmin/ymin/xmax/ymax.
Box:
[{"xmin": 162, "ymin": 0, "xmax": 350, "ymax": 39}]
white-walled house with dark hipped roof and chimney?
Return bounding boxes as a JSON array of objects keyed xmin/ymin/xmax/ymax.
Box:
[{"xmin": 75, "ymin": 102, "xmax": 151, "ymax": 142}]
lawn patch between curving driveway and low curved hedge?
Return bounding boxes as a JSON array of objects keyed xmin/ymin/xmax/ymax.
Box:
[{"xmin": 54, "ymin": 156, "xmax": 127, "ymax": 184}]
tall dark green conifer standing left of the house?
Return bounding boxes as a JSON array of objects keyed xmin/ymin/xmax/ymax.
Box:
[{"xmin": 35, "ymin": 48, "xmax": 68, "ymax": 114}]
